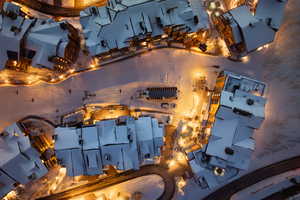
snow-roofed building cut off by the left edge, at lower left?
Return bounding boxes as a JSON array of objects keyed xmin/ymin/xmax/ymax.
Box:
[{"xmin": 0, "ymin": 124, "xmax": 48, "ymax": 198}]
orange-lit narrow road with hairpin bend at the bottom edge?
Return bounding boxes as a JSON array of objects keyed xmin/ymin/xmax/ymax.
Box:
[{"xmin": 37, "ymin": 165, "xmax": 176, "ymax": 200}]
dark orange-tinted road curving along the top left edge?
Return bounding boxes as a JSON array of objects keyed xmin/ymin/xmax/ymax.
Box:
[{"xmin": 12, "ymin": 0, "xmax": 106, "ymax": 17}]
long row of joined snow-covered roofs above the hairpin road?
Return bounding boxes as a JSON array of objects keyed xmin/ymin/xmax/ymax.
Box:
[{"xmin": 54, "ymin": 117, "xmax": 164, "ymax": 176}]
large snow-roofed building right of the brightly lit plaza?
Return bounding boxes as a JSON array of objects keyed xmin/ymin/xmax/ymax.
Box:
[{"xmin": 188, "ymin": 72, "xmax": 266, "ymax": 188}]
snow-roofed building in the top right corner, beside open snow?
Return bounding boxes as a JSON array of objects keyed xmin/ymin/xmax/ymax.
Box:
[{"xmin": 213, "ymin": 0, "xmax": 287, "ymax": 57}]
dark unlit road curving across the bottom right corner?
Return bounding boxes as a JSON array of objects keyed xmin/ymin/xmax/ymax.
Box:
[{"xmin": 202, "ymin": 156, "xmax": 300, "ymax": 200}]
